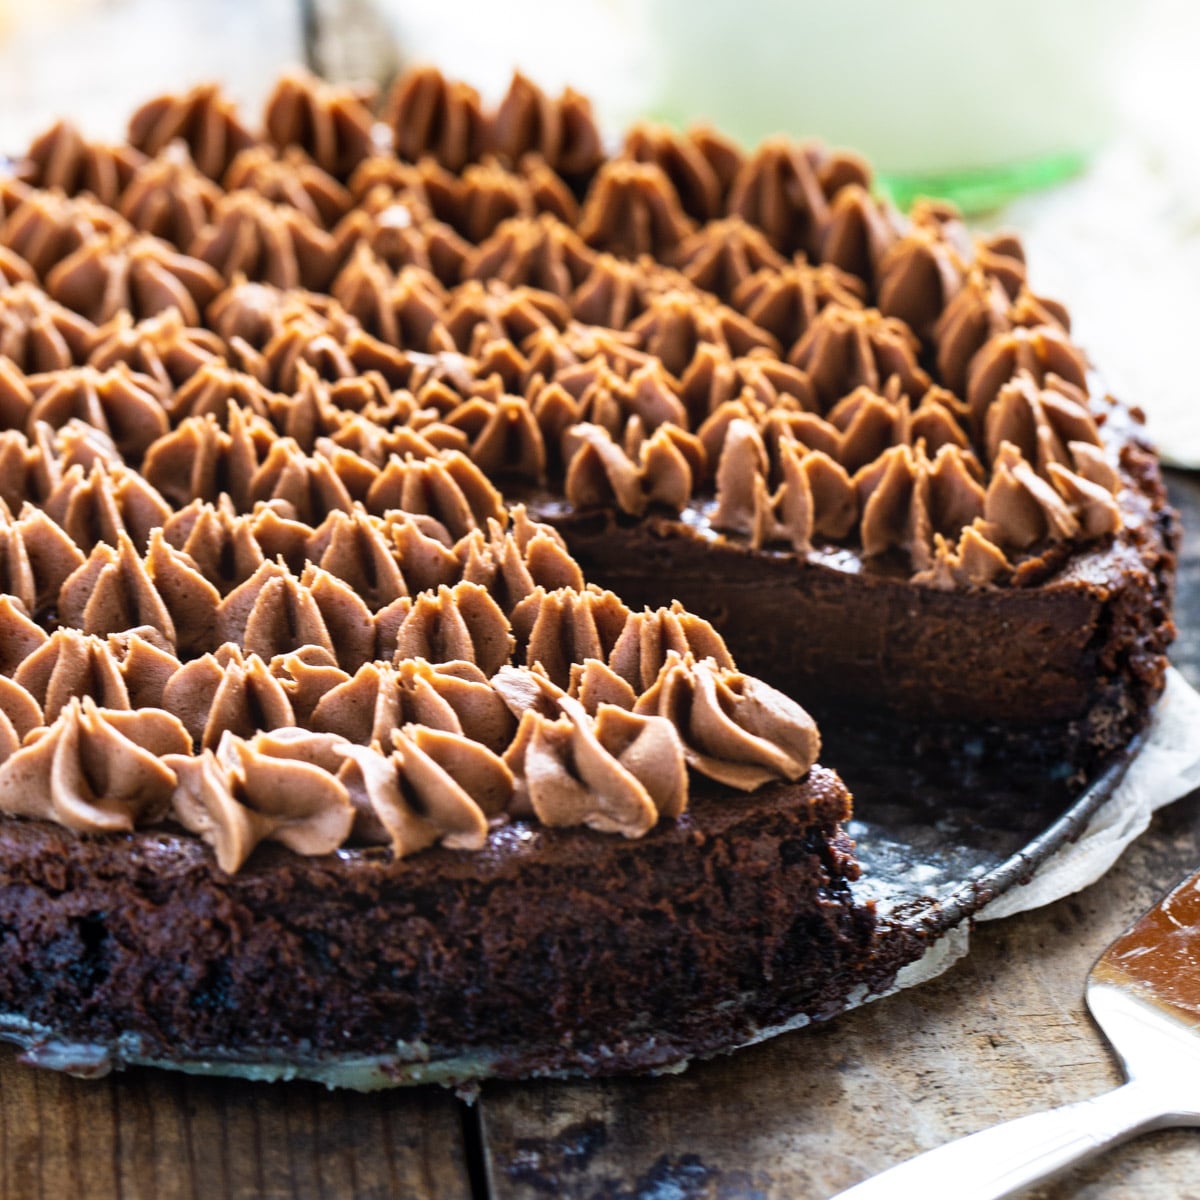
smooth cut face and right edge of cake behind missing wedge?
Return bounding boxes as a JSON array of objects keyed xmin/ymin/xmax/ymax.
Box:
[{"xmin": 540, "ymin": 409, "xmax": 1180, "ymax": 779}]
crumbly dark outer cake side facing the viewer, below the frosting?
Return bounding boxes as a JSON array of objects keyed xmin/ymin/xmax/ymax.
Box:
[{"xmin": 0, "ymin": 768, "xmax": 920, "ymax": 1076}]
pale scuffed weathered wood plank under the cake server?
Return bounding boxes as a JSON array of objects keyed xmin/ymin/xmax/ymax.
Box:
[{"xmin": 481, "ymin": 475, "xmax": 1200, "ymax": 1200}]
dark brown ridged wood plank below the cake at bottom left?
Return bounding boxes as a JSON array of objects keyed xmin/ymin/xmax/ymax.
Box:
[{"xmin": 0, "ymin": 1046, "xmax": 470, "ymax": 1200}]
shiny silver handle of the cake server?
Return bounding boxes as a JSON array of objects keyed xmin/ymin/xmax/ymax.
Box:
[{"xmin": 833, "ymin": 1080, "xmax": 1176, "ymax": 1200}]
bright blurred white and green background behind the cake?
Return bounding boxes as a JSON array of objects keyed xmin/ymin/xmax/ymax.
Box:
[{"xmin": 0, "ymin": 0, "xmax": 1200, "ymax": 456}]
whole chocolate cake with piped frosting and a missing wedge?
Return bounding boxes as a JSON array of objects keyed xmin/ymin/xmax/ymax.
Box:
[{"xmin": 0, "ymin": 70, "xmax": 1176, "ymax": 1086}]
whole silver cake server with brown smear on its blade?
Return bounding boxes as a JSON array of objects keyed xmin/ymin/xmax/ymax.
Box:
[{"xmin": 833, "ymin": 871, "xmax": 1200, "ymax": 1200}]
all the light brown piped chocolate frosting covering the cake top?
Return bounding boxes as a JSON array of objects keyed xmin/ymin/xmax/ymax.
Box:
[{"xmin": 0, "ymin": 60, "xmax": 1142, "ymax": 871}]
